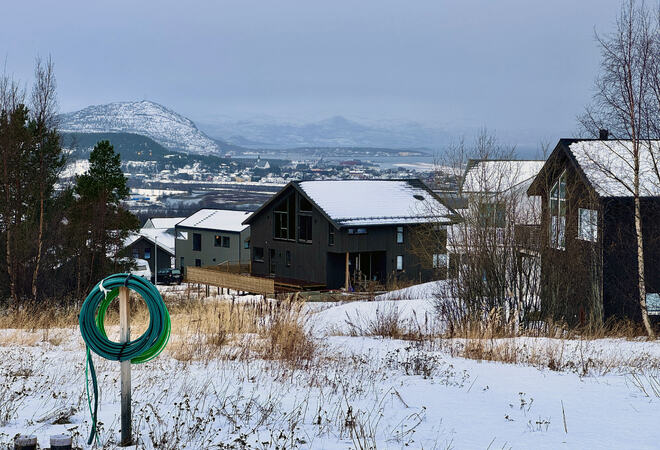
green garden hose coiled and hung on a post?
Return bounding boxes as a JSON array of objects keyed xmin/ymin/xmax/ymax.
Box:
[{"xmin": 78, "ymin": 273, "xmax": 171, "ymax": 445}]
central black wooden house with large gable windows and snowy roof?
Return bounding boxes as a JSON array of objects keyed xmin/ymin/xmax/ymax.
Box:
[{"xmin": 244, "ymin": 180, "xmax": 452, "ymax": 289}]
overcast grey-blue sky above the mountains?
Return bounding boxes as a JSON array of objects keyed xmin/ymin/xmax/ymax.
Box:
[{"xmin": 0, "ymin": 0, "xmax": 620, "ymax": 140}]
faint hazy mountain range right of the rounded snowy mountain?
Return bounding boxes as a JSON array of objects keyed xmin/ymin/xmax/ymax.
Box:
[{"xmin": 199, "ymin": 116, "xmax": 449, "ymax": 150}]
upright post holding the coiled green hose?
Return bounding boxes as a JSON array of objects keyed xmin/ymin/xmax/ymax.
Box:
[{"xmin": 119, "ymin": 286, "xmax": 133, "ymax": 447}]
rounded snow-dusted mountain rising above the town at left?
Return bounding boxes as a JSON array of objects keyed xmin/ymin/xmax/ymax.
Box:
[{"xmin": 60, "ymin": 100, "xmax": 220, "ymax": 154}]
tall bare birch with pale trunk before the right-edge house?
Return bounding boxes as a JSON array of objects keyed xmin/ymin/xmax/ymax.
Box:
[{"xmin": 580, "ymin": 0, "xmax": 660, "ymax": 337}]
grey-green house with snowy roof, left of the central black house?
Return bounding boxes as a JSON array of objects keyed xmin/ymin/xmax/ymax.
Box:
[{"xmin": 175, "ymin": 209, "xmax": 251, "ymax": 272}]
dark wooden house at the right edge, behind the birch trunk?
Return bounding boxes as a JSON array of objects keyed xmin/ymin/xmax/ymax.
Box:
[{"xmin": 527, "ymin": 136, "xmax": 660, "ymax": 324}]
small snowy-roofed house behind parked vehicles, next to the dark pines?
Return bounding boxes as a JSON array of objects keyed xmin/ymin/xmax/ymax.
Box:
[{"xmin": 124, "ymin": 227, "xmax": 174, "ymax": 273}]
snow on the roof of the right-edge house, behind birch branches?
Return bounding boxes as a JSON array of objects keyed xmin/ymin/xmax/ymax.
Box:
[{"xmin": 569, "ymin": 140, "xmax": 660, "ymax": 197}]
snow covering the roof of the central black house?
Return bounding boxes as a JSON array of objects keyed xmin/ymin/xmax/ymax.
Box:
[{"xmin": 298, "ymin": 180, "xmax": 451, "ymax": 226}]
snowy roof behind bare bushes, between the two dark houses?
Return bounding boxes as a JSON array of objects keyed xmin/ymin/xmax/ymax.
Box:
[{"xmin": 462, "ymin": 159, "xmax": 545, "ymax": 193}]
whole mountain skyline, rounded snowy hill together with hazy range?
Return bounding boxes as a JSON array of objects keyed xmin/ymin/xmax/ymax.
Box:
[{"xmin": 60, "ymin": 101, "xmax": 532, "ymax": 156}]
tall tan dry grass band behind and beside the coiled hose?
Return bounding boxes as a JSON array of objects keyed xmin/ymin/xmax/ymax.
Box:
[{"xmin": 0, "ymin": 291, "xmax": 317, "ymax": 367}]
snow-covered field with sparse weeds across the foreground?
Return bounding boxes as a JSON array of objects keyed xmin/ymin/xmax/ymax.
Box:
[{"xmin": 0, "ymin": 287, "xmax": 660, "ymax": 449}]
